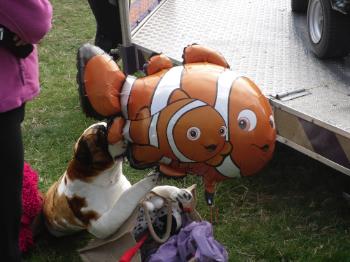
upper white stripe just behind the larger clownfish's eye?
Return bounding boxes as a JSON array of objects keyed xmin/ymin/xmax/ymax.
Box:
[{"xmin": 215, "ymin": 70, "xmax": 239, "ymax": 140}]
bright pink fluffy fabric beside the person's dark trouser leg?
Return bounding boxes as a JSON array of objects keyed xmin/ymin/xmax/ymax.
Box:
[{"xmin": 19, "ymin": 163, "xmax": 43, "ymax": 253}]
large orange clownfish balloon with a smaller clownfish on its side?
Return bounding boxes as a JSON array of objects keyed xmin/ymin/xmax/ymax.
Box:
[{"xmin": 77, "ymin": 44, "xmax": 276, "ymax": 205}]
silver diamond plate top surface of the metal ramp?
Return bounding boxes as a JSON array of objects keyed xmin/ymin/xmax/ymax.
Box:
[{"xmin": 133, "ymin": 0, "xmax": 350, "ymax": 134}]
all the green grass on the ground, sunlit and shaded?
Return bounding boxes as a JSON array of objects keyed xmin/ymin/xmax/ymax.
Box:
[{"xmin": 23, "ymin": 0, "xmax": 350, "ymax": 261}]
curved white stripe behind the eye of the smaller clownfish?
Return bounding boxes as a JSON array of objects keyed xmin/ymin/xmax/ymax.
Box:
[{"xmin": 166, "ymin": 100, "xmax": 207, "ymax": 163}]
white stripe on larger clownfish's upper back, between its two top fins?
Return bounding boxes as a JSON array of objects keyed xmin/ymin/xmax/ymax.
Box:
[{"xmin": 151, "ymin": 66, "xmax": 183, "ymax": 115}]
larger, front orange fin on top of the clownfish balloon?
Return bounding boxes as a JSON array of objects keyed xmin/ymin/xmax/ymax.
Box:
[{"xmin": 182, "ymin": 44, "xmax": 230, "ymax": 68}]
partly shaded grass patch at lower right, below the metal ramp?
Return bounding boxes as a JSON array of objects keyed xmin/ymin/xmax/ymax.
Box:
[{"xmin": 215, "ymin": 144, "xmax": 350, "ymax": 261}]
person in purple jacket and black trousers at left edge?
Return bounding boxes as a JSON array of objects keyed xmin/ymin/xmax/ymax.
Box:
[{"xmin": 0, "ymin": 0, "xmax": 52, "ymax": 261}]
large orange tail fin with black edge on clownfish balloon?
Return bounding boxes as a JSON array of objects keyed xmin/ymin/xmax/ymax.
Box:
[{"xmin": 77, "ymin": 44, "xmax": 125, "ymax": 120}]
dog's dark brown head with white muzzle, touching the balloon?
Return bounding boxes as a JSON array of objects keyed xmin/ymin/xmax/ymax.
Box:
[{"xmin": 68, "ymin": 122, "xmax": 126, "ymax": 180}]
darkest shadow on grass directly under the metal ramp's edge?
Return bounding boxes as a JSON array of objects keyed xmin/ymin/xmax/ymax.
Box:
[{"xmin": 247, "ymin": 144, "xmax": 350, "ymax": 218}]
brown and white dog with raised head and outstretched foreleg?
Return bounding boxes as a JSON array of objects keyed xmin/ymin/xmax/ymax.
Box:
[{"xmin": 43, "ymin": 123, "xmax": 158, "ymax": 238}]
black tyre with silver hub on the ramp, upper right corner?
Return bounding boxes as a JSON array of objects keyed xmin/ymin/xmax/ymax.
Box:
[{"xmin": 307, "ymin": 0, "xmax": 350, "ymax": 58}]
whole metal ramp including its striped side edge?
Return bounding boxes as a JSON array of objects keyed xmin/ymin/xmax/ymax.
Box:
[{"xmin": 132, "ymin": 0, "xmax": 350, "ymax": 175}]
